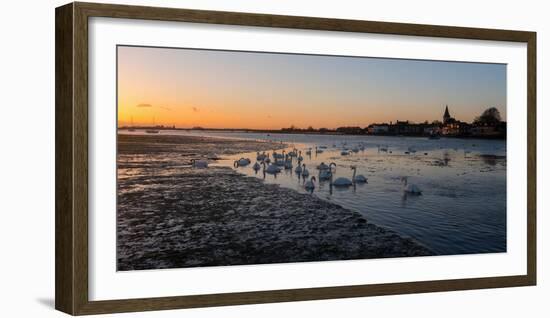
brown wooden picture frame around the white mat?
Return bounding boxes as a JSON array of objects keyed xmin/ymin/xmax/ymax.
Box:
[{"xmin": 55, "ymin": 2, "xmax": 536, "ymax": 315}]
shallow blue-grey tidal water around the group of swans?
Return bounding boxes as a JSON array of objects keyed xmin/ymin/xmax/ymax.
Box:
[{"xmin": 121, "ymin": 131, "xmax": 506, "ymax": 255}]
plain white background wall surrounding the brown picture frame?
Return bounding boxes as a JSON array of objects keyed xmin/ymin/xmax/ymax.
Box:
[{"xmin": 0, "ymin": 0, "xmax": 550, "ymax": 317}]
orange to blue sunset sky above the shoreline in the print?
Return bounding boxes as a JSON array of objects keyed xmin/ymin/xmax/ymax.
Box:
[{"xmin": 118, "ymin": 46, "xmax": 506, "ymax": 129}]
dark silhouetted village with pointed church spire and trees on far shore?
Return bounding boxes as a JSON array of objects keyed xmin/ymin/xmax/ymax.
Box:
[{"xmin": 282, "ymin": 105, "xmax": 506, "ymax": 139}]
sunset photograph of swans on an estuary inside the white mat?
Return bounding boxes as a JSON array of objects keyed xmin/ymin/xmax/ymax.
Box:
[{"xmin": 116, "ymin": 45, "xmax": 513, "ymax": 271}]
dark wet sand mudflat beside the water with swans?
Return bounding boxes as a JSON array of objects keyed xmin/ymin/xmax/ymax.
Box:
[{"xmin": 117, "ymin": 135, "xmax": 432, "ymax": 271}]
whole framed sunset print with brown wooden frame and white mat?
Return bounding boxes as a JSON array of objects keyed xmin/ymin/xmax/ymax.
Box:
[{"xmin": 56, "ymin": 2, "xmax": 536, "ymax": 315}]
